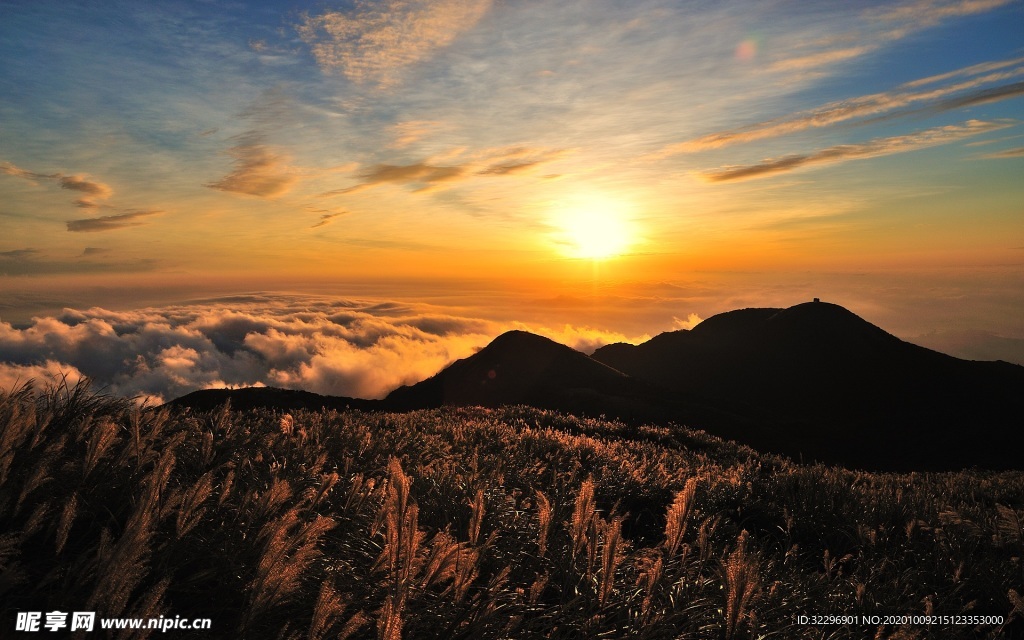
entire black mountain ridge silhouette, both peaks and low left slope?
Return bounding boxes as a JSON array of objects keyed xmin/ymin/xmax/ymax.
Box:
[{"xmin": 172, "ymin": 302, "xmax": 1024, "ymax": 470}]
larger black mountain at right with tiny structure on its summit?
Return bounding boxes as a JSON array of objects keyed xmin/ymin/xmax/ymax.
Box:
[{"xmin": 593, "ymin": 302, "xmax": 1024, "ymax": 469}]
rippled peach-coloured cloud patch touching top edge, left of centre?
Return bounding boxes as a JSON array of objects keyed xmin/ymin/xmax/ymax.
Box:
[{"xmin": 297, "ymin": 0, "xmax": 492, "ymax": 86}]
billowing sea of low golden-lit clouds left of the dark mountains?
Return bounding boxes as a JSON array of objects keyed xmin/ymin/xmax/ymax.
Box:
[{"xmin": 0, "ymin": 295, "xmax": 638, "ymax": 401}]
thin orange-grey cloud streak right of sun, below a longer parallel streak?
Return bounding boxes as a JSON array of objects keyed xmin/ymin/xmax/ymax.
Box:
[{"xmin": 699, "ymin": 120, "xmax": 1009, "ymax": 182}]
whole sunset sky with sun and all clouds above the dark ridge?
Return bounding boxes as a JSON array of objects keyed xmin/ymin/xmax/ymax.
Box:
[{"xmin": 0, "ymin": 0, "xmax": 1024, "ymax": 400}]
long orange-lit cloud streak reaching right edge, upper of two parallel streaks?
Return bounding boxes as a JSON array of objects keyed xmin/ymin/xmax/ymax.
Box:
[{"xmin": 657, "ymin": 57, "xmax": 1024, "ymax": 158}]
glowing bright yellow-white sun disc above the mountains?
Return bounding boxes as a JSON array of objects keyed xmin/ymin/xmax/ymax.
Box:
[{"xmin": 555, "ymin": 203, "xmax": 633, "ymax": 260}]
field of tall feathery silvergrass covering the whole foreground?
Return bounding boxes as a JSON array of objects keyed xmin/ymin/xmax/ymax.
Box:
[{"xmin": 0, "ymin": 386, "xmax": 1024, "ymax": 640}]
